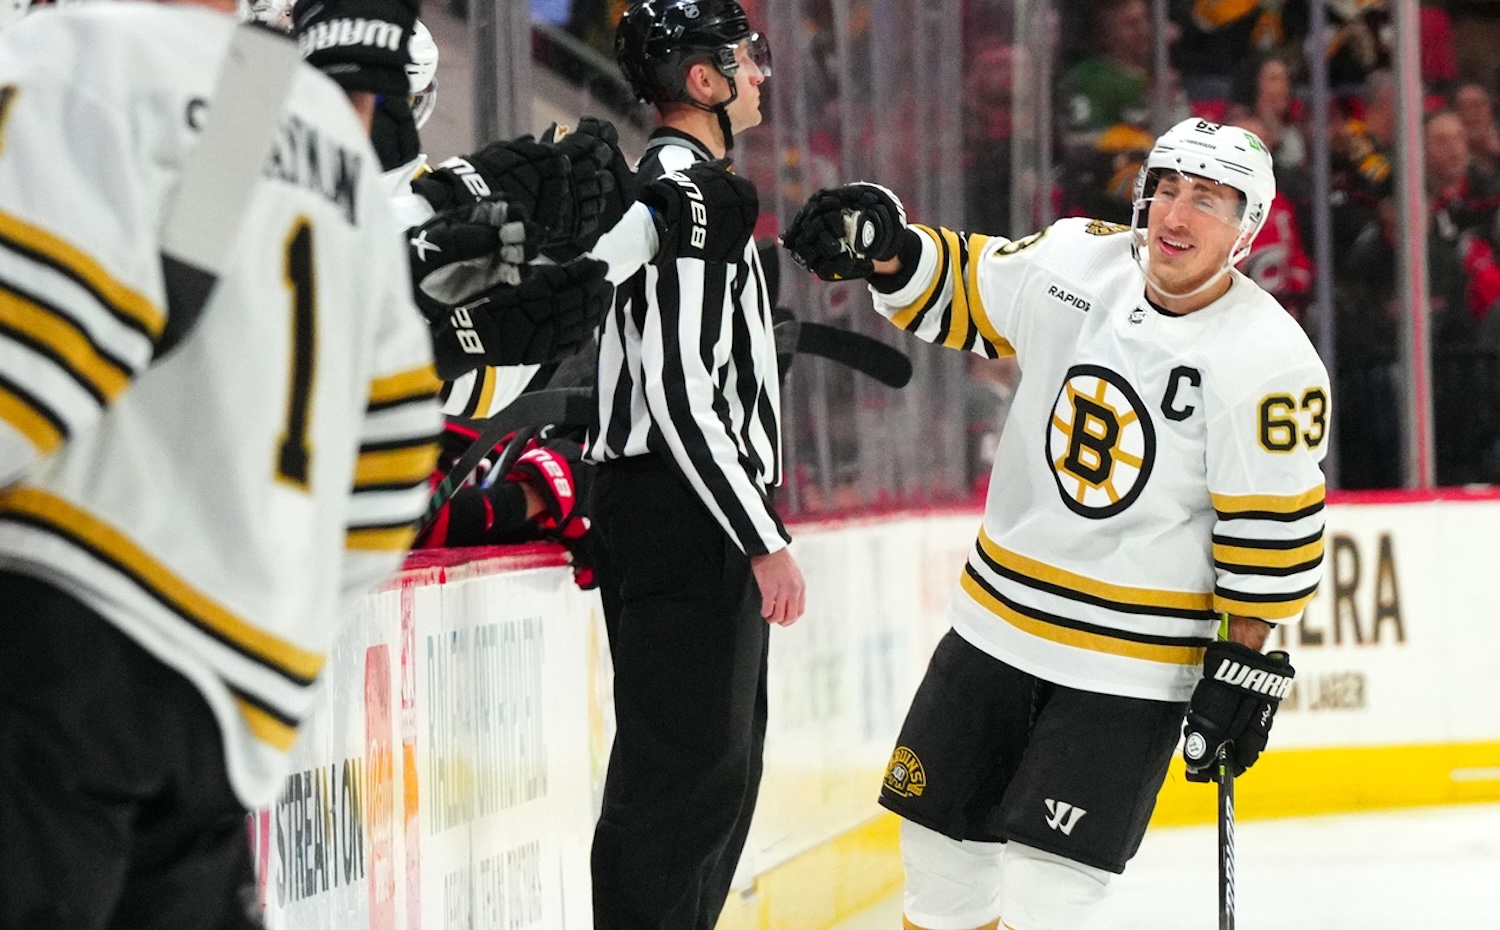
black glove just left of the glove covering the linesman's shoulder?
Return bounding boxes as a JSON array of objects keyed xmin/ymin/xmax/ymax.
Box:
[{"xmin": 542, "ymin": 117, "xmax": 636, "ymax": 251}]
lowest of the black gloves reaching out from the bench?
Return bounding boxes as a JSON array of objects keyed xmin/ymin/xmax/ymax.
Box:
[{"xmin": 417, "ymin": 258, "xmax": 614, "ymax": 381}]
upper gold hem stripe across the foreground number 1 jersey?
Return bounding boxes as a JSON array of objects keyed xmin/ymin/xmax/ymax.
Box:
[{"xmin": 0, "ymin": 486, "xmax": 324, "ymax": 687}]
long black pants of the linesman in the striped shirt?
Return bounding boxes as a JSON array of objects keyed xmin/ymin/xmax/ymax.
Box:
[{"xmin": 593, "ymin": 456, "xmax": 770, "ymax": 930}]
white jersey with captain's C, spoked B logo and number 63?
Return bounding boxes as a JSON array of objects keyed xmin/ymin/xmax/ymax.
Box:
[{"xmin": 875, "ymin": 219, "xmax": 1332, "ymax": 701}]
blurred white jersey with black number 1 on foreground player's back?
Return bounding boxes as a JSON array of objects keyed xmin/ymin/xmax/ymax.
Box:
[{"xmin": 0, "ymin": 3, "xmax": 440, "ymax": 806}]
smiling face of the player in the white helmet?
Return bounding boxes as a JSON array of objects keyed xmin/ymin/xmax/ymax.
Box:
[{"xmin": 1146, "ymin": 174, "xmax": 1244, "ymax": 294}]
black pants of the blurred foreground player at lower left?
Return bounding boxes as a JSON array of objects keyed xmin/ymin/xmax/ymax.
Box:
[{"xmin": 0, "ymin": 572, "xmax": 261, "ymax": 930}]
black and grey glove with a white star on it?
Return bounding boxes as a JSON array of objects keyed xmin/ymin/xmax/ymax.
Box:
[{"xmin": 407, "ymin": 198, "xmax": 540, "ymax": 318}]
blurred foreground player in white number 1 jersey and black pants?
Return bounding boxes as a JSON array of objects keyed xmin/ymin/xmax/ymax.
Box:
[{"xmin": 0, "ymin": 0, "xmax": 440, "ymax": 930}]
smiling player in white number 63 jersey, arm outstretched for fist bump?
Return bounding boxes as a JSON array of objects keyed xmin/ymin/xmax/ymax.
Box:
[{"xmin": 785, "ymin": 120, "xmax": 1331, "ymax": 930}]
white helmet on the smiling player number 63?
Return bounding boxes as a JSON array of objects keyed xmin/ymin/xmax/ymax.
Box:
[{"xmin": 1131, "ymin": 119, "xmax": 1277, "ymax": 267}]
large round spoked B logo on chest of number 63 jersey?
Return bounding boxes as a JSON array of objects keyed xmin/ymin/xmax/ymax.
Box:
[{"xmin": 1047, "ymin": 365, "xmax": 1157, "ymax": 519}]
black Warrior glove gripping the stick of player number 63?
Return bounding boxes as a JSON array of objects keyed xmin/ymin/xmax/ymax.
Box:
[{"xmin": 1182, "ymin": 642, "xmax": 1296, "ymax": 782}]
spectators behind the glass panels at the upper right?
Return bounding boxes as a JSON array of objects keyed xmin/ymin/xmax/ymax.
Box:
[{"xmin": 968, "ymin": 0, "xmax": 1500, "ymax": 489}]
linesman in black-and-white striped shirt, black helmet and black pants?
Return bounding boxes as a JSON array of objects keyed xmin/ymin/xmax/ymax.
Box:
[{"xmin": 585, "ymin": 0, "xmax": 804, "ymax": 930}]
